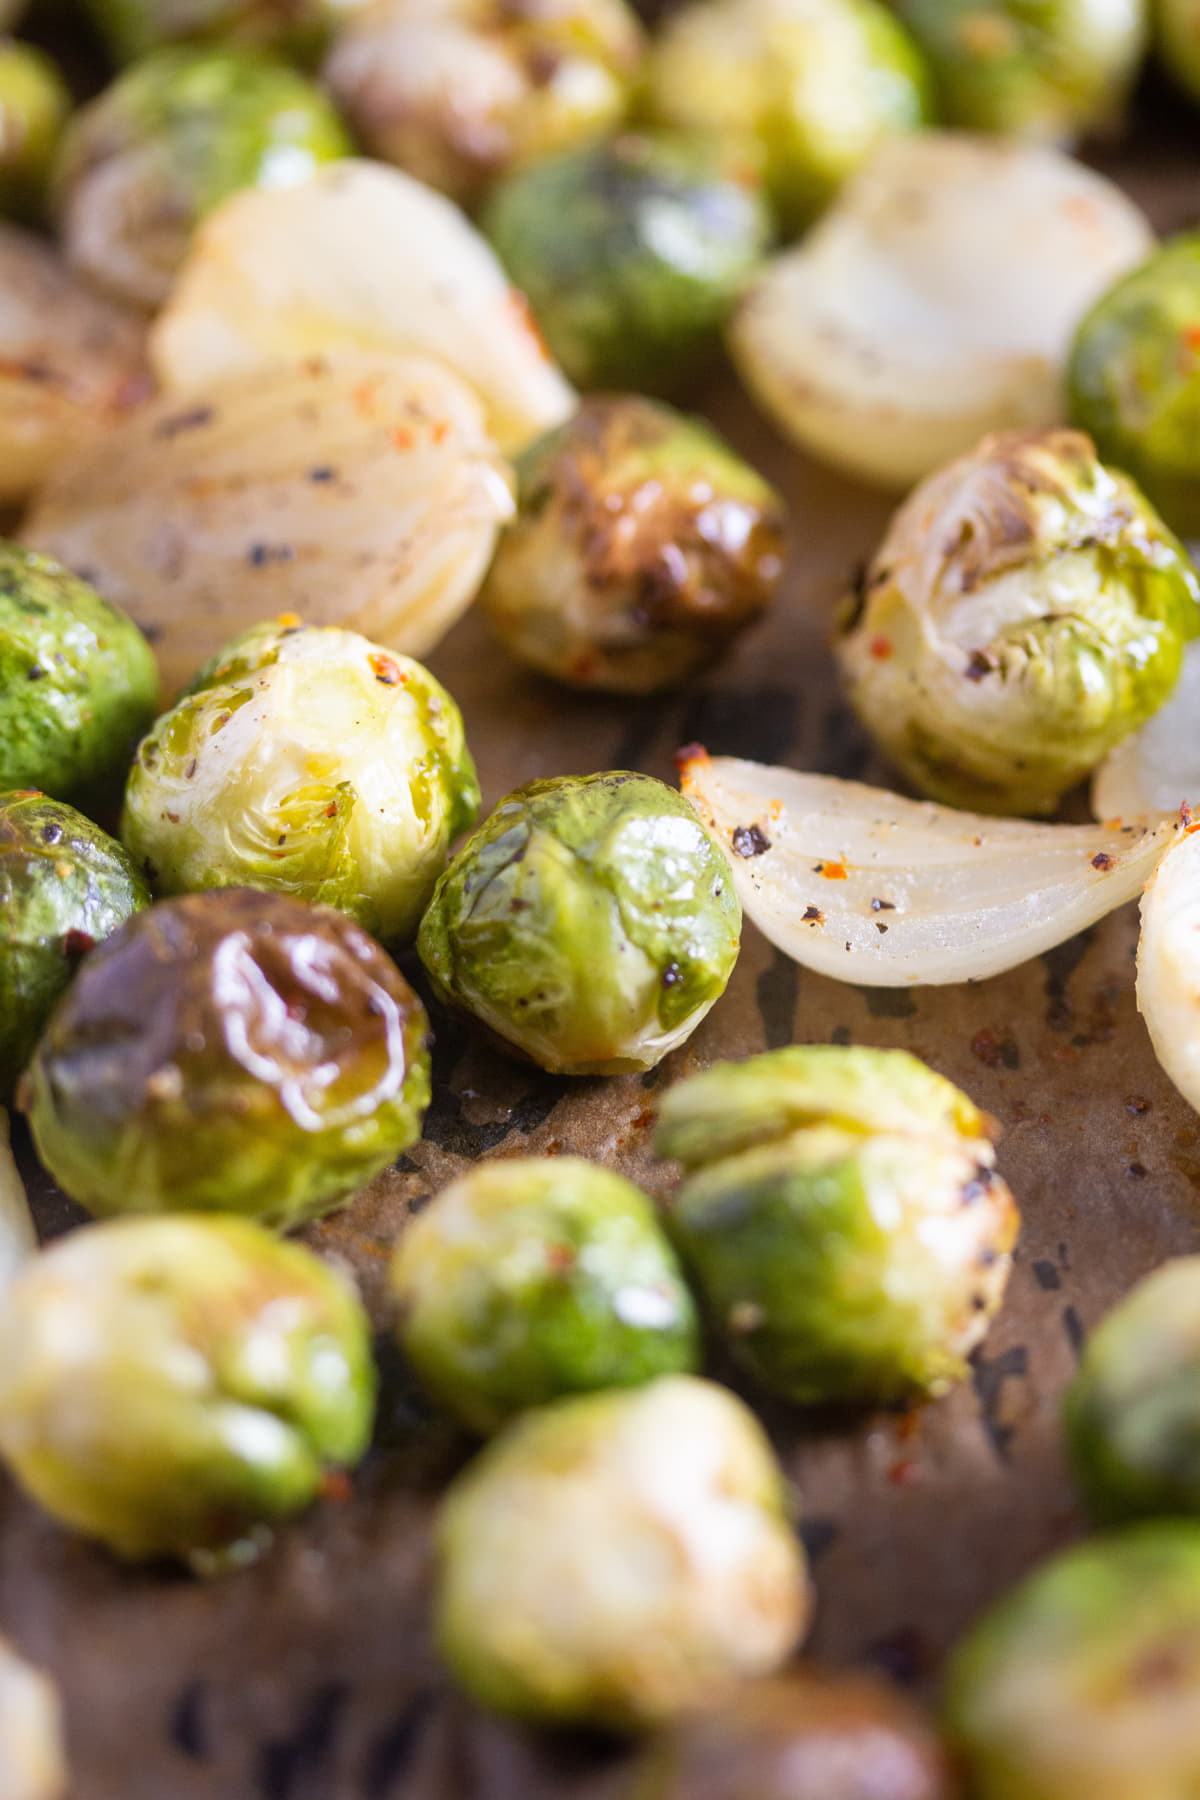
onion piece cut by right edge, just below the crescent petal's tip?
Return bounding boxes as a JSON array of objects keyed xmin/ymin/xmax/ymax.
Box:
[{"xmin": 1137, "ymin": 824, "xmax": 1200, "ymax": 1109}]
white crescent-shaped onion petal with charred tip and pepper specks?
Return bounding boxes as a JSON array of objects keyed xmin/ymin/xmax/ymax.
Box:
[{"xmin": 682, "ymin": 751, "xmax": 1178, "ymax": 988}]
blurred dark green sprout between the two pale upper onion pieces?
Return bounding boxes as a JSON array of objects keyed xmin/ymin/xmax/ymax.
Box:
[{"xmin": 482, "ymin": 135, "xmax": 770, "ymax": 394}]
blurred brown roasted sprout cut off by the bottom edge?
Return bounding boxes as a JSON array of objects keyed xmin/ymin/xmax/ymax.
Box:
[{"xmin": 628, "ymin": 1667, "xmax": 952, "ymax": 1800}]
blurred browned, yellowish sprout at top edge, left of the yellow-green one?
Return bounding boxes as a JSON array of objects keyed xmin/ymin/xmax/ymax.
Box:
[{"xmin": 324, "ymin": 0, "xmax": 642, "ymax": 205}]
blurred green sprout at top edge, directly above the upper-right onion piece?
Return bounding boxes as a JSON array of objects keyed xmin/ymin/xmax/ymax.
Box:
[{"xmin": 900, "ymin": 0, "xmax": 1148, "ymax": 144}]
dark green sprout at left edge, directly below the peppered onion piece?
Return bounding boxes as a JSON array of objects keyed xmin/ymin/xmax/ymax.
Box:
[{"xmin": 0, "ymin": 542, "xmax": 158, "ymax": 812}]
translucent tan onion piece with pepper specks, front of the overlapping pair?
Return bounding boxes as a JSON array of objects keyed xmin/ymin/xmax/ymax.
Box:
[{"xmin": 23, "ymin": 349, "xmax": 513, "ymax": 698}]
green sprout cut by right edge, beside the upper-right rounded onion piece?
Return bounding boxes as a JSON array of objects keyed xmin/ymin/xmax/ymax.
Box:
[{"xmin": 1067, "ymin": 232, "xmax": 1200, "ymax": 538}]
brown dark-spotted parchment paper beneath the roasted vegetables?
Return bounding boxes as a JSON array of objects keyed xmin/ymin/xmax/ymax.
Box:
[{"xmin": 0, "ymin": 112, "xmax": 1200, "ymax": 1800}]
